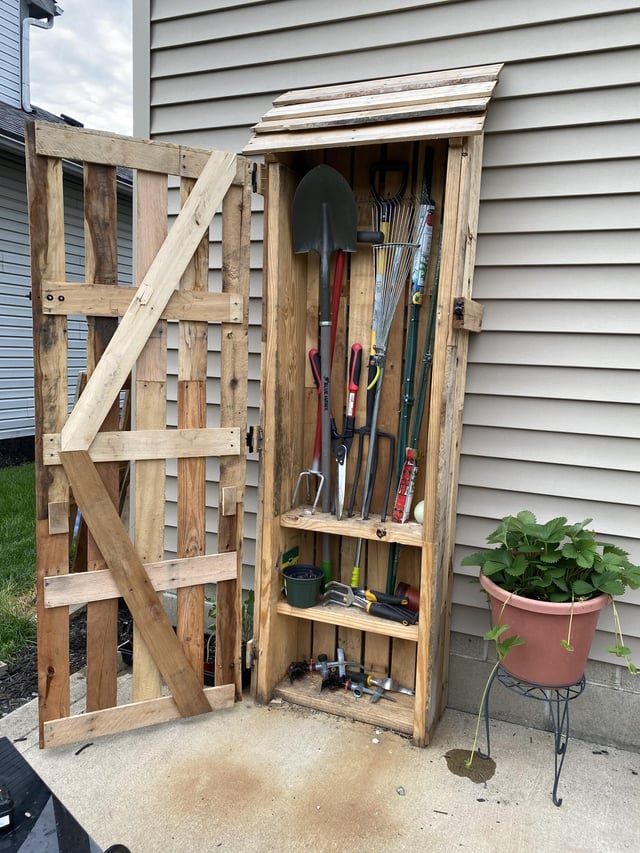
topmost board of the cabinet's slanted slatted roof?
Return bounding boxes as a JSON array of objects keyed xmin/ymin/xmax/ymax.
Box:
[{"xmin": 273, "ymin": 63, "xmax": 503, "ymax": 106}]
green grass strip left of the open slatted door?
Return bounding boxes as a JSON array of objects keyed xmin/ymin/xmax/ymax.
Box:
[{"xmin": 0, "ymin": 464, "xmax": 36, "ymax": 663}]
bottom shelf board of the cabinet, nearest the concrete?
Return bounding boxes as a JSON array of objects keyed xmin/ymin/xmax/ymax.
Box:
[{"xmin": 274, "ymin": 674, "xmax": 414, "ymax": 735}]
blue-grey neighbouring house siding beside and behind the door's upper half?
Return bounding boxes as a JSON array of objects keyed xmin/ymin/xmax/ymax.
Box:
[{"xmin": 0, "ymin": 150, "xmax": 132, "ymax": 439}]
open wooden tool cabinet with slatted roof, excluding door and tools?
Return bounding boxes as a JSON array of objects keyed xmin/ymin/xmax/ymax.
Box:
[{"xmin": 244, "ymin": 65, "xmax": 501, "ymax": 746}]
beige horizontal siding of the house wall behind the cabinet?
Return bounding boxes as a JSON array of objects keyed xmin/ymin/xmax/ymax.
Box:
[{"xmin": 134, "ymin": 0, "xmax": 640, "ymax": 662}]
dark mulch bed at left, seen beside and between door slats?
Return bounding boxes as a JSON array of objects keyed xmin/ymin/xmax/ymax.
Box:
[{"xmin": 0, "ymin": 606, "xmax": 131, "ymax": 717}]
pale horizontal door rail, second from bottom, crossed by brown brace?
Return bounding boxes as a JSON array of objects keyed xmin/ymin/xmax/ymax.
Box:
[{"xmin": 44, "ymin": 551, "xmax": 237, "ymax": 607}]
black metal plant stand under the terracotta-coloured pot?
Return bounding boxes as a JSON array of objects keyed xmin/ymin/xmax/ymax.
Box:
[{"xmin": 478, "ymin": 664, "xmax": 585, "ymax": 806}]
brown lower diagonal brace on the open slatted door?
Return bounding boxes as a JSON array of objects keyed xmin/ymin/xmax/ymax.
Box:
[{"xmin": 61, "ymin": 450, "xmax": 210, "ymax": 717}]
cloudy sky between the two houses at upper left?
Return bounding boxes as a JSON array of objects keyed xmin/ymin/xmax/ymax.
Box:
[{"xmin": 30, "ymin": 0, "xmax": 133, "ymax": 134}]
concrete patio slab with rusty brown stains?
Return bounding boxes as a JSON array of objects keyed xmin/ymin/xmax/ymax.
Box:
[{"xmin": 0, "ymin": 678, "xmax": 640, "ymax": 853}]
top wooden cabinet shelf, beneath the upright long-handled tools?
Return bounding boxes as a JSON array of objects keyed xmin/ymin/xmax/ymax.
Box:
[{"xmin": 280, "ymin": 506, "xmax": 424, "ymax": 548}]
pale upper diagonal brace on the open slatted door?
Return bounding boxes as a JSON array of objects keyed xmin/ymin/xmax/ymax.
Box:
[{"xmin": 62, "ymin": 146, "xmax": 236, "ymax": 450}]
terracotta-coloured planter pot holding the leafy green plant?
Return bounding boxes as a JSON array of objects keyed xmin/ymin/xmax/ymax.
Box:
[{"xmin": 480, "ymin": 573, "xmax": 610, "ymax": 687}]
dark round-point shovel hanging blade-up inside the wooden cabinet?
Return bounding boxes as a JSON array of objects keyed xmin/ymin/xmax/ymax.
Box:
[{"xmin": 292, "ymin": 164, "xmax": 358, "ymax": 583}]
